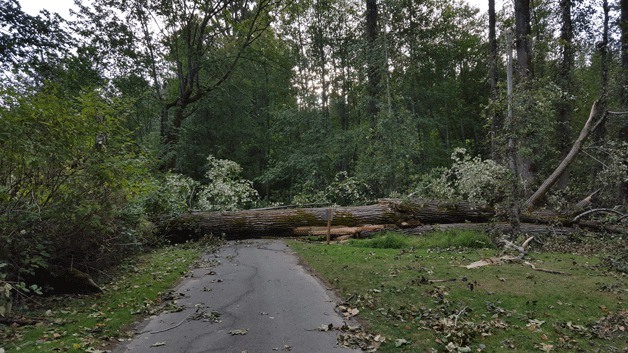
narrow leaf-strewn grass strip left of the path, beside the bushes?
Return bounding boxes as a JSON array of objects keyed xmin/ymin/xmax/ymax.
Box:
[{"xmin": 0, "ymin": 239, "xmax": 216, "ymax": 353}]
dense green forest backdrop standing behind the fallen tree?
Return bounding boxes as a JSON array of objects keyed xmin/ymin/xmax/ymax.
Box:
[{"xmin": 0, "ymin": 0, "xmax": 628, "ymax": 315}]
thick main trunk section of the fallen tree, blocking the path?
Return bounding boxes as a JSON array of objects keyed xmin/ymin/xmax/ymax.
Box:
[{"xmin": 161, "ymin": 199, "xmax": 495, "ymax": 242}]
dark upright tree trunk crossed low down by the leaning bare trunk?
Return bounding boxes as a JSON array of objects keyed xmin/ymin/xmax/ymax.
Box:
[{"xmin": 556, "ymin": 0, "xmax": 574, "ymax": 188}]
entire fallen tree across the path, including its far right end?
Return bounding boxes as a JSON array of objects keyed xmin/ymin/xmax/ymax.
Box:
[{"xmin": 161, "ymin": 199, "xmax": 627, "ymax": 242}]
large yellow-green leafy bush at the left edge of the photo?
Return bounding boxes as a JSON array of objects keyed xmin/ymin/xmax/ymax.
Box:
[{"xmin": 0, "ymin": 87, "xmax": 150, "ymax": 312}]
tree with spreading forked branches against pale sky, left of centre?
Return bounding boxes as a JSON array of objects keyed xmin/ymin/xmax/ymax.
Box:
[{"xmin": 75, "ymin": 0, "xmax": 278, "ymax": 169}]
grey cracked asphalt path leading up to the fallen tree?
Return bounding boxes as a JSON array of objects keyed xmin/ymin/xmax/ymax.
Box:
[{"xmin": 114, "ymin": 240, "xmax": 360, "ymax": 353}]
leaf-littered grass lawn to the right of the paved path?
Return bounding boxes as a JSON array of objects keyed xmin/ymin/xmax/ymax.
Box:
[{"xmin": 291, "ymin": 232, "xmax": 628, "ymax": 352}]
